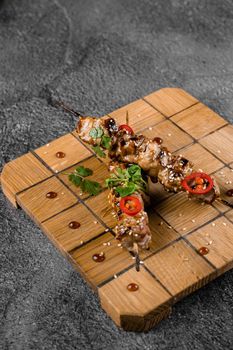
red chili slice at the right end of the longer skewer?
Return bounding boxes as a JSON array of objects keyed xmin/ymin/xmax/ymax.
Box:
[{"xmin": 181, "ymin": 172, "xmax": 214, "ymax": 194}]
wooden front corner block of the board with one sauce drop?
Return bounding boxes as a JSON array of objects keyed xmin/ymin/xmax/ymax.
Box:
[{"xmin": 98, "ymin": 268, "xmax": 171, "ymax": 331}]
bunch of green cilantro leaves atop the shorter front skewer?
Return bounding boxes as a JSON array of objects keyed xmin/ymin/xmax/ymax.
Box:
[{"xmin": 105, "ymin": 164, "xmax": 147, "ymax": 197}]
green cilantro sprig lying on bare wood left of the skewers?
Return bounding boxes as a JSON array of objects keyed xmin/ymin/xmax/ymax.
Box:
[{"xmin": 63, "ymin": 165, "xmax": 102, "ymax": 196}]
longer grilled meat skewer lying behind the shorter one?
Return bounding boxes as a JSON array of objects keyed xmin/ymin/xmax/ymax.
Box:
[{"xmin": 77, "ymin": 117, "xmax": 220, "ymax": 203}]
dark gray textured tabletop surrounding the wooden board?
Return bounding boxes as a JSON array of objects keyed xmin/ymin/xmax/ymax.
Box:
[{"xmin": 0, "ymin": 0, "xmax": 233, "ymax": 350}]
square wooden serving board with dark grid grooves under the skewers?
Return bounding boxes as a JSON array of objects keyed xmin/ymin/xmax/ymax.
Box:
[{"xmin": 1, "ymin": 88, "xmax": 233, "ymax": 331}]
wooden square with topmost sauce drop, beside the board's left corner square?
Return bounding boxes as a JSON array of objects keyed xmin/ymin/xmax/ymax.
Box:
[{"xmin": 35, "ymin": 134, "xmax": 92, "ymax": 172}]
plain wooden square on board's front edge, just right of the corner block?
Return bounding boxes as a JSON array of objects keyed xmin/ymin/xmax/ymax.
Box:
[{"xmin": 145, "ymin": 241, "xmax": 214, "ymax": 300}]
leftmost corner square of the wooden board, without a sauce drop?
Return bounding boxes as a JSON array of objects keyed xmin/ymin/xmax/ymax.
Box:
[{"xmin": 1, "ymin": 153, "xmax": 52, "ymax": 206}]
